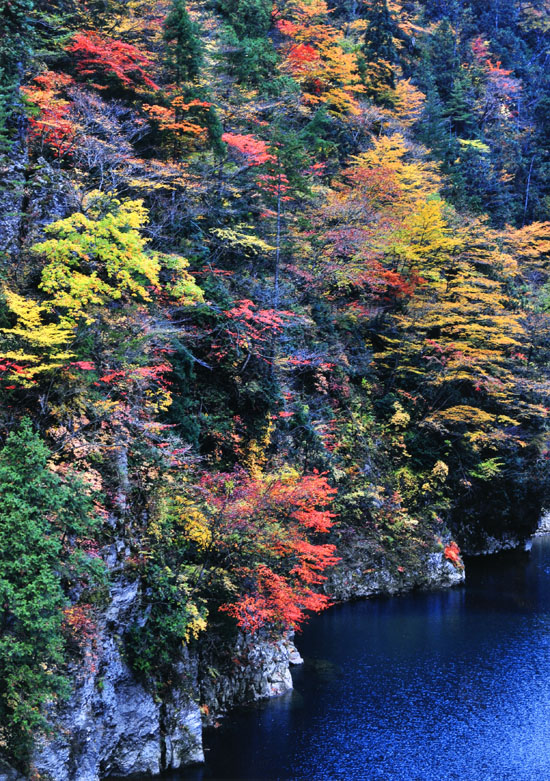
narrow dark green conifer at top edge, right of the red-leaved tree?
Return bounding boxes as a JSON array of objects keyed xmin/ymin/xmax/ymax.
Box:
[{"xmin": 164, "ymin": 0, "xmax": 202, "ymax": 84}]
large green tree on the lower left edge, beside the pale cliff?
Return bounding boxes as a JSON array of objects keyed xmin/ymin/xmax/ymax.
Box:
[{"xmin": 0, "ymin": 419, "xmax": 101, "ymax": 769}]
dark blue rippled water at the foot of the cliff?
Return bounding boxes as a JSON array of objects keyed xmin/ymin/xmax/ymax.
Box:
[{"xmin": 181, "ymin": 537, "xmax": 550, "ymax": 781}]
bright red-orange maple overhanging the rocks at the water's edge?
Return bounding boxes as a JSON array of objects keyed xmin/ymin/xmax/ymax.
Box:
[{"xmin": 201, "ymin": 472, "xmax": 338, "ymax": 632}]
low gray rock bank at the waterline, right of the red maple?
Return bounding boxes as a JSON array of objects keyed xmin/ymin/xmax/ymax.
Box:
[{"xmin": 325, "ymin": 538, "xmax": 464, "ymax": 601}]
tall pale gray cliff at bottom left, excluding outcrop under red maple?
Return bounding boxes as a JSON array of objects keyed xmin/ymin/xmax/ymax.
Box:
[{"xmin": 33, "ymin": 582, "xmax": 203, "ymax": 781}]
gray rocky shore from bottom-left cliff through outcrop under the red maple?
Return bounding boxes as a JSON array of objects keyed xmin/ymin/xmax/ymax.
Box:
[{"xmin": 24, "ymin": 581, "xmax": 301, "ymax": 781}]
